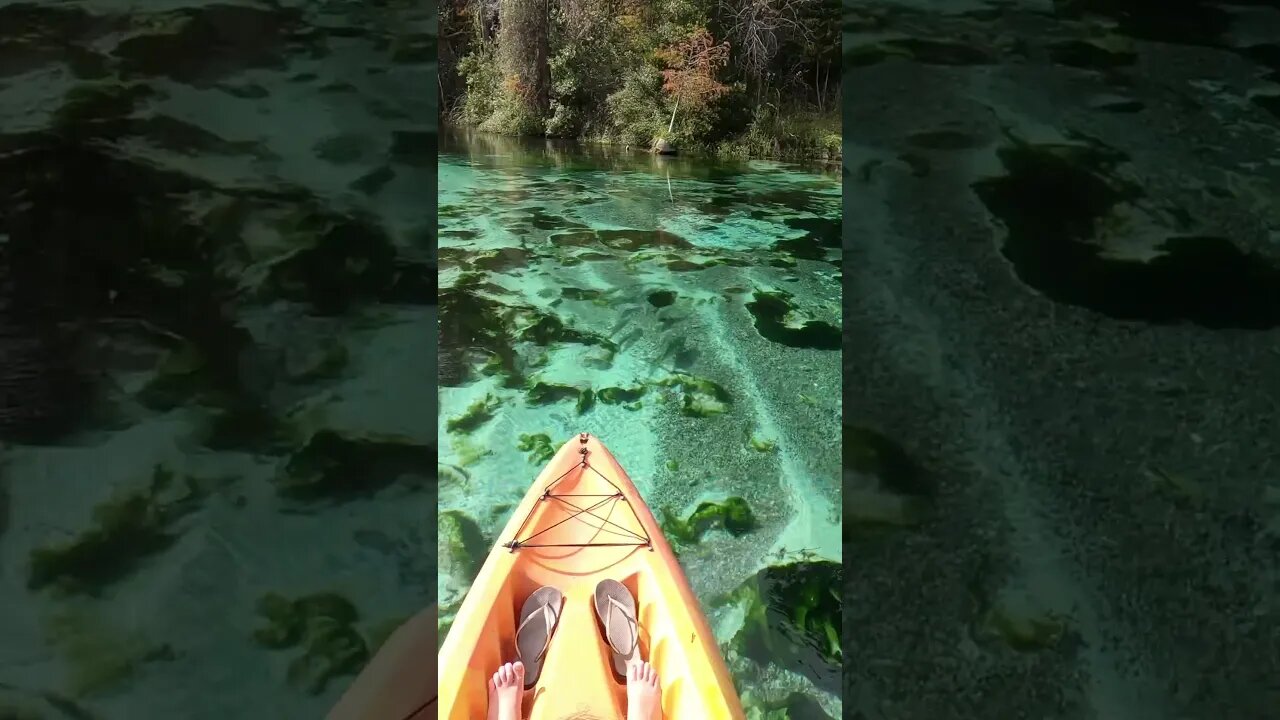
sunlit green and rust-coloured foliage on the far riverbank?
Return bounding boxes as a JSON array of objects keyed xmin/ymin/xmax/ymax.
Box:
[{"xmin": 442, "ymin": 0, "xmax": 841, "ymax": 160}]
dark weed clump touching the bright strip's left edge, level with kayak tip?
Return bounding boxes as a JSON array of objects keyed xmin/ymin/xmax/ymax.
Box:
[{"xmin": 274, "ymin": 429, "xmax": 435, "ymax": 501}]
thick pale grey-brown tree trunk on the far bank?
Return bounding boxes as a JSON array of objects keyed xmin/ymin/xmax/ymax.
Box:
[{"xmin": 498, "ymin": 0, "xmax": 550, "ymax": 120}]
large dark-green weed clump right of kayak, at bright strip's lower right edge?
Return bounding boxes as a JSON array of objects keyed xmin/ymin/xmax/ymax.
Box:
[{"xmin": 717, "ymin": 561, "xmax": 844, "ymax": 692}]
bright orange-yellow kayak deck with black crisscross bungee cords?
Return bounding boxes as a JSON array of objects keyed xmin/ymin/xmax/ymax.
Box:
[{"xmin": 439, "ymin": 436, "xmax": 744, "ymax": 720}]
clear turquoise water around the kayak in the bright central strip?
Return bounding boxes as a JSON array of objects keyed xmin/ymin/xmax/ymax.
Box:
[{"xmin": 438, "ymin": 133, "xmax": 841, "ymax": 717}]
